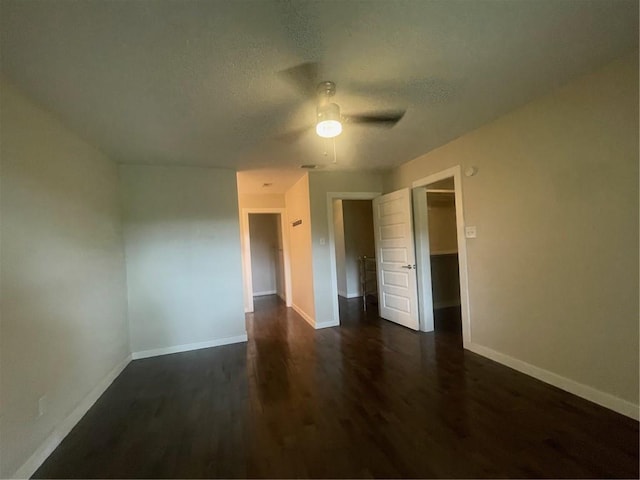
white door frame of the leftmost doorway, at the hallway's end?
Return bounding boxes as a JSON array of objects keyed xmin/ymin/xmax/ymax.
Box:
[{"xmin": 240, "ymin": 208, "xmax": 291, "ymax": 313}]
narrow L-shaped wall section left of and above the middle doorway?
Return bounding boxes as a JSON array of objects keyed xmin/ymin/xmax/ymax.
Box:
[{"xmin": 309, "ymin": 172, "xmax": 382, "ymax": 326}]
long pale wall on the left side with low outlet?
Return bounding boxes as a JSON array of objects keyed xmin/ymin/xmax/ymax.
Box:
[{"xmin": 0, "ymin": 82, "xmax": 129, "ymax": 478}]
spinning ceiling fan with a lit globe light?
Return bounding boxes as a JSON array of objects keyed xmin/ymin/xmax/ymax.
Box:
[{"xmin": 277, "ymin": 62, "xmax": 406, "ymax": 142}]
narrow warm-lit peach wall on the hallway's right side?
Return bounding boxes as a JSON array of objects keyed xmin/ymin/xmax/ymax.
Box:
[{"xmin": 285, "ymin": 175, "xmax": 316, "ymax": 324}]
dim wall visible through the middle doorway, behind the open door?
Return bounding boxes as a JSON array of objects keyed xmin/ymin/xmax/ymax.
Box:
[{"xmin": 342, "ymin": 200, "xmax": 376, "ymax": 298}]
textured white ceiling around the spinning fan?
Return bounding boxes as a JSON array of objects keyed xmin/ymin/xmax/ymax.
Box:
[{"xmin": 1, "ymin": 0, "xmax": 638, "ymax": 181}]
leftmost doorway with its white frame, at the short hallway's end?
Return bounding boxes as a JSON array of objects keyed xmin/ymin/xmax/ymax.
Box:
[{"xmin": 242, "ymin": 208, "xmax": 291, "ymax": 313}]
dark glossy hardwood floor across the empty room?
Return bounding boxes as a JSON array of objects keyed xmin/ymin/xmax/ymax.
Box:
[{"xmin": 35, "ymin": 297, "xmax": 638, "ymax": 478}]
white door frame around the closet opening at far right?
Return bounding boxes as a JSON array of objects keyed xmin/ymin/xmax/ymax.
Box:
[{"xmin": 412, "ymin": 165, "xmax": 471, "ymax": 348}]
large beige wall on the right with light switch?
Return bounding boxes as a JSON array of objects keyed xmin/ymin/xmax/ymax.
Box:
[{"xmin": 386, "ymin": 52, "xmax": 639, "ymax": 415}]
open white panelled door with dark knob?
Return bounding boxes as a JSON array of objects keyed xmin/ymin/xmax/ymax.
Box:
[{"xmin": 373, "ymin": 188, "xmax": 418, "ymax": 330}]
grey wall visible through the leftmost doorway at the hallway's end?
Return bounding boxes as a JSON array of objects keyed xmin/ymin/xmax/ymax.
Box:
[{"xmin": 249, "ymin": 213, "xmax": 279, "ymax": 296}]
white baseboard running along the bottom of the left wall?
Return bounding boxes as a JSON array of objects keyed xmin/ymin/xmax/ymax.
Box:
[{"xmin": 11, "ymin": 355, "xmax": 131, "ymax": 478}]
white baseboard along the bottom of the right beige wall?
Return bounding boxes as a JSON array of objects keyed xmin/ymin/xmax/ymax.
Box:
[{"xmin": 465, "ymin": 343, "xmax": 640, "ymax": 420}]
